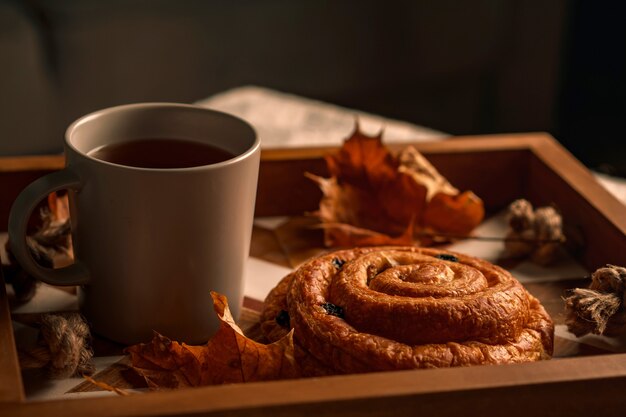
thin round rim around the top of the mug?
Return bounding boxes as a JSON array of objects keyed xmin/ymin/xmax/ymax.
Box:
[{"xmin": 64, "ymin": 102, "xmax": 261, "ymax": 172}]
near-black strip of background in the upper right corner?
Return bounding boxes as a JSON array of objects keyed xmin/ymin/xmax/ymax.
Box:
[{"xmin": 549, "ymin": 1, "xmax": 626, "ymax": 176}]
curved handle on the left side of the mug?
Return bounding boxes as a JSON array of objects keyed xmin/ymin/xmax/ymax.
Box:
[{"xmin": 8, "ymin": 168, "xmax": 89, "ymax": 285}]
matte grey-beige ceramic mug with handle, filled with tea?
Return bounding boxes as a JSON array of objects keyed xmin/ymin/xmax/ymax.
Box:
[{"xmin": 9, "ymin": 103, "xmax": 260, "ymax": 344}]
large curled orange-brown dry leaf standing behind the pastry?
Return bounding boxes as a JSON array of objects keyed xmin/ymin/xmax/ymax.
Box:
[{"xmin": 307, "ymin": 124, "xmax": 484, "ymax": 246}]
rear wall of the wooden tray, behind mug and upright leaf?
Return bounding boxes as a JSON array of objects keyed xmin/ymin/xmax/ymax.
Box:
[{"xmin": 0, "ymin": 135, "xmax": 534, "ymax": 231}]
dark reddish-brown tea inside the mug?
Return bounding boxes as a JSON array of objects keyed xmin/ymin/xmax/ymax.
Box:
[{"xmin": 88, "ymin": 139, "xmax": 235, "ymax": 169}]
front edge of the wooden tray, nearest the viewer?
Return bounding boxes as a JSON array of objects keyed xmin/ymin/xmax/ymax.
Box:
[{"xmin": 0, "ymin": 354, "xmax": 626, "ymax": 417}]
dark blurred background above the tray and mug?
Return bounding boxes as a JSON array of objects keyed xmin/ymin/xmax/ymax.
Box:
[{"xmin": 0, "ymin": 0, "xmax": 626, "ymax": 176}]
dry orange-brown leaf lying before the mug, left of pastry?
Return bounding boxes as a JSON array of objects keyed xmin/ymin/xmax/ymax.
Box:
[{"xmin": 126, "ymin": 292, "xmax": 299, "ymax": 389}]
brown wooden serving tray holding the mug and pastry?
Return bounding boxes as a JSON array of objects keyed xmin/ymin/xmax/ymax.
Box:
[{"xmin": 0, "ymin": 134, "xmax": 626, "ymax": 417}]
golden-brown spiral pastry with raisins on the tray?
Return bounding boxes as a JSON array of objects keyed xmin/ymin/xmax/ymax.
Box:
[{"xmin": 261, "ymin": 247, "xmax": 554, "ymax": 375}]
